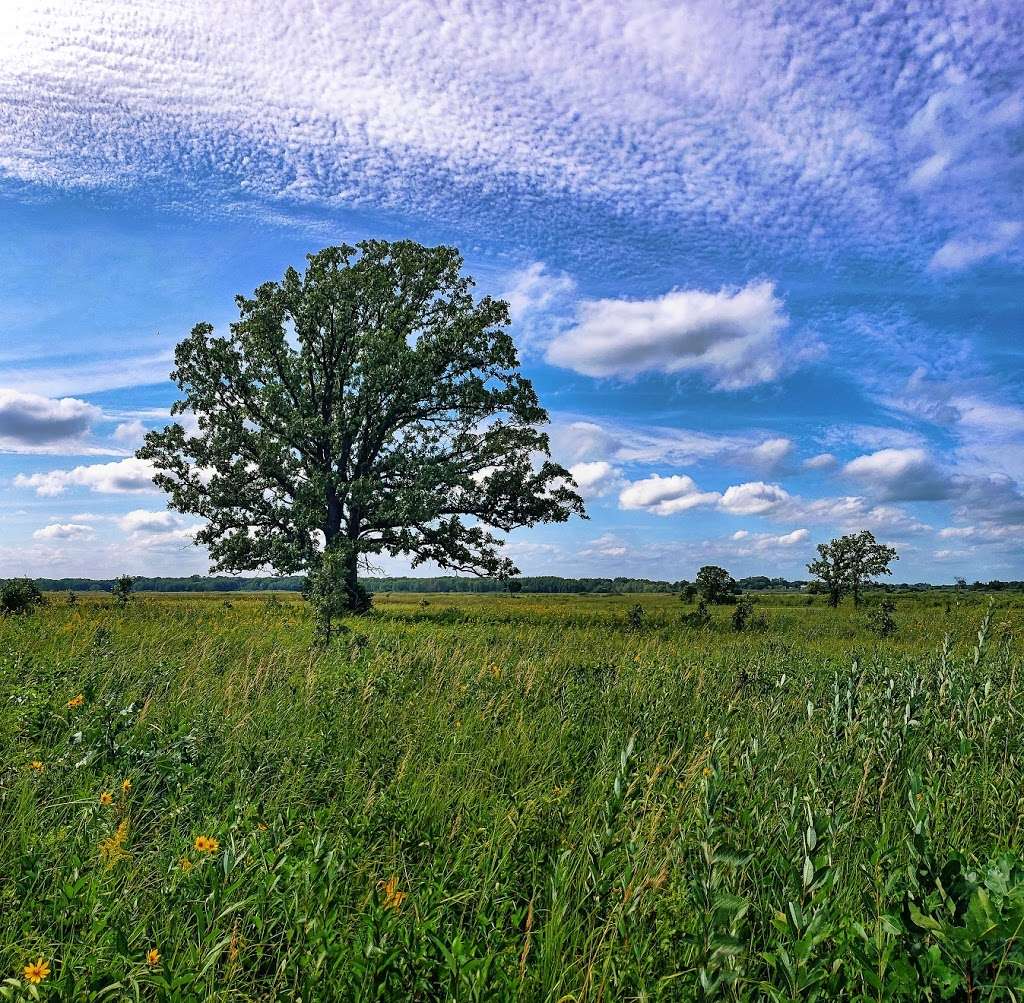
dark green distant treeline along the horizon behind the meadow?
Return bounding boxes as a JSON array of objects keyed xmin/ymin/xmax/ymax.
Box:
[{"xmin": 25, "ymin": 575, "xmax": 1024, "ymax": 595}]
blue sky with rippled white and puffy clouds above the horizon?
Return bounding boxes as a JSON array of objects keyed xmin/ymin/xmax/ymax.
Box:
[{"xmin": 0, "ymin": 0, "xmax": 1024, "ymax": 582}]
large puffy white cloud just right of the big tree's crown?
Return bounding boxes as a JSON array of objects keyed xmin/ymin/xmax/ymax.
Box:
[{"xmin": 545, "ymin": 282, "xmax": 788, "ymax": 389}]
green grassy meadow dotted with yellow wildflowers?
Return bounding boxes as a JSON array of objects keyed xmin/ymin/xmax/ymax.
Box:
[{"xmin": 0, "ymin": 593, "xmax": 1024, "ymax": 1003}]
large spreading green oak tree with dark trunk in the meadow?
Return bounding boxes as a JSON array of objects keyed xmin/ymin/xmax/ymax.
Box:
[{"xmin": 137, "ymin": 241, "xmax": 586, "ymax": 636}]
